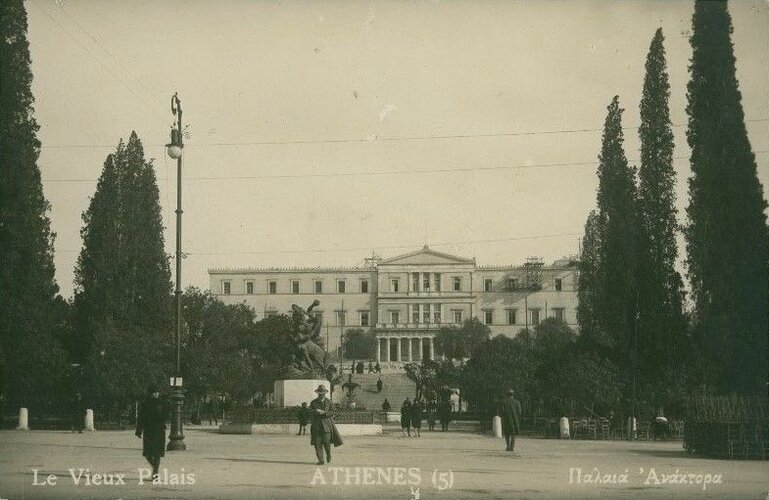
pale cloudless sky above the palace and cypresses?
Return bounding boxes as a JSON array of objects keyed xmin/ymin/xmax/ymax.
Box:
[{"xmin": 26, "ymin": 0, "xmax": 769, "ymax": 297}]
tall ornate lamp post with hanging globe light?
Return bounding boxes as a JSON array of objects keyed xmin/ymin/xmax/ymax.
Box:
[{"xmin": 166, "ymin": 94, "xmax": 187, "ymax": 451}]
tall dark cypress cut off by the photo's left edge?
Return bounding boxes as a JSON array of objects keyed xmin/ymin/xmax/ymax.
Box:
[{"xmin": 0, "ymin": 0, "xmax": 68, "ymax": 407}]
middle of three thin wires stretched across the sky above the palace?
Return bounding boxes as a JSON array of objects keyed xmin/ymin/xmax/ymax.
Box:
[{"xmin": 42, "ymin": 150, "xmax": 769, "ymax": 183}]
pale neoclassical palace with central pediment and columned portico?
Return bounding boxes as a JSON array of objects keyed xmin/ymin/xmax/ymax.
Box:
[{"xmin": 208, "ymin": 246, "xmax": 578, "ymax": 368}]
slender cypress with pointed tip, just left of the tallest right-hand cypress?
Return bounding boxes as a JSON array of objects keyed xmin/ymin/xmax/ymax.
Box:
[{"xmin": 638, "ymin": 29, "xmax": 688, "ymax": 398}]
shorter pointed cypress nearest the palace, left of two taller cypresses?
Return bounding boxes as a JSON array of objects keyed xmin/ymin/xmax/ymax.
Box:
[{"xmin": 596, "ymin": 96, "xmax": 639, "ymax": 366}]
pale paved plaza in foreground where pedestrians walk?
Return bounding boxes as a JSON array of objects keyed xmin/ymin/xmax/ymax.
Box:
[{"xmin": 0, "ymin": 428, "xmax": 769, "ymax": 500}]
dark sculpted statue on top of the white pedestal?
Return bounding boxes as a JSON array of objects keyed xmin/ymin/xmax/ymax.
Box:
[{"xmin": 282, "ymin": 299, "xmax": 328, "ymax": 379}]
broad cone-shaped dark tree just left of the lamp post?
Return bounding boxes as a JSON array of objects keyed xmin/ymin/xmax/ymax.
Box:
[{"xmin": 74, "ymin": 132, "xmax": 172, "ymax": 401}]
